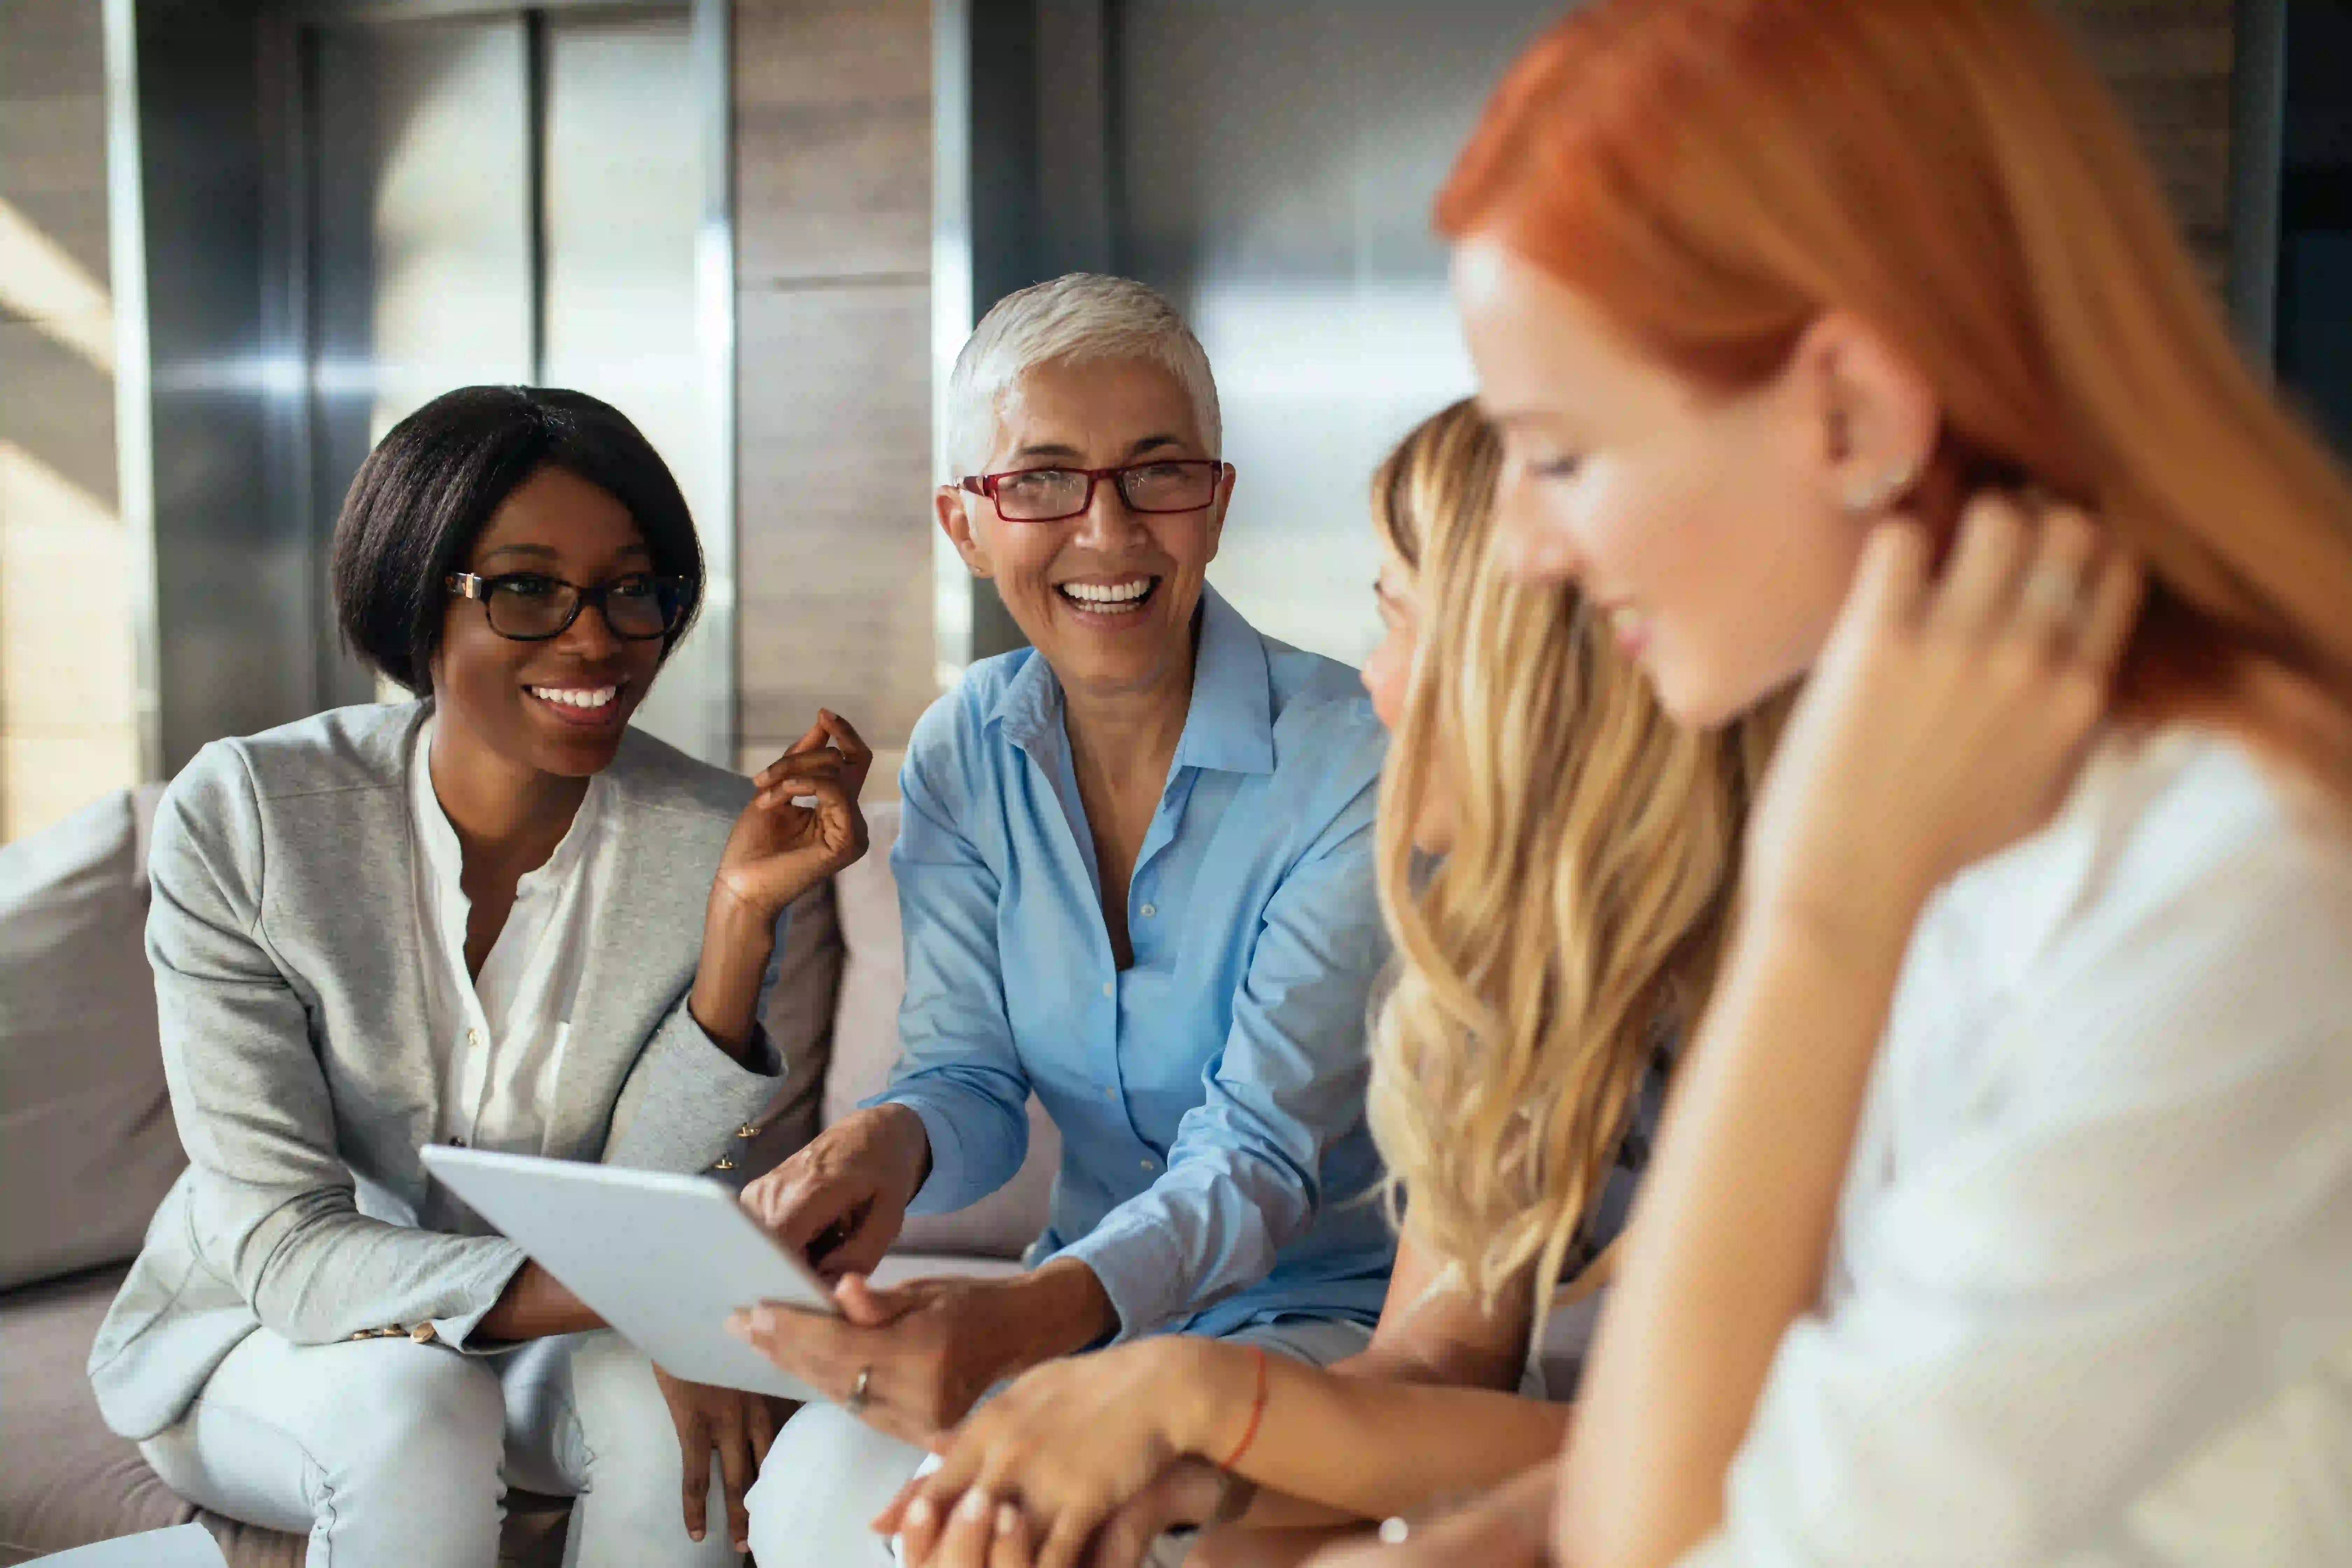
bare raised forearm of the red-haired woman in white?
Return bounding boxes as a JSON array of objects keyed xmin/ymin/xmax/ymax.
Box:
[{"xmin": 1557, "ymin": 910, "xmax": 1912, "ymax": 1568}]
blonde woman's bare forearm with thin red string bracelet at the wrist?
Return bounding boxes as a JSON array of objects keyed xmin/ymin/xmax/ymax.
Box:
[{"xmin": 1183, "ymin": 1340, "xmax": 1569, "ymax": 1523}]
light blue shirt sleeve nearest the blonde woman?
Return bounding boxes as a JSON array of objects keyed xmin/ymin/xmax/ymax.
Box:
[{"xmin": 1061, "ymin": 780, "xmax": 1385, "ymax": 1340}]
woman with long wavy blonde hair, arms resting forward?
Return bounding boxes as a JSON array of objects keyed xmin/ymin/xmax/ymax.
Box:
[{"xmin": 880, "ymin": 402, "xmax": 1764, "ymax": 1568}]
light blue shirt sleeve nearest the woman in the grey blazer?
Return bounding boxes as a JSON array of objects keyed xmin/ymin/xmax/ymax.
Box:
[{"xmin": 868, "ymin": 757, "xmax": 1030, "ymax": 1213}]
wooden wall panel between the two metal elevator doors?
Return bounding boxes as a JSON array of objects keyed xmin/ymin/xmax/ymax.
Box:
[{"xmin": 734, "ymin": 0, "xmax": 936, "ymax": 794}]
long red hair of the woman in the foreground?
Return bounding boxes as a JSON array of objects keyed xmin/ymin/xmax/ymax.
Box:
[{"xmin": 1437, "ymin": 0, "xmax": 2352, "ymax": 794}]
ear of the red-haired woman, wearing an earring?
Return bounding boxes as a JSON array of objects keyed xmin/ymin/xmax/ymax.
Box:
[{"xmin": 1790, "ymin": 310, "xmax": 1943, "ymax": 515}]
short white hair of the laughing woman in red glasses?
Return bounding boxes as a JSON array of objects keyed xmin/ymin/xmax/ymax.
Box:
[{"xmin": 945, "ymin": 273, "xmax": 1225, "ymax": 484}]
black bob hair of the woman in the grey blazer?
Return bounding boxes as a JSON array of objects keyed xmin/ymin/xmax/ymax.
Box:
[{"xmin": 334, "ymin": 386, "xmax": 703, "ymax": 696}]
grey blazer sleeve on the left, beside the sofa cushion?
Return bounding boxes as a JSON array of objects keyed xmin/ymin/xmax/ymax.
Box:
[{"xmin": 148, "ymin": 743, "xmax": 522, "ymax": 1347}]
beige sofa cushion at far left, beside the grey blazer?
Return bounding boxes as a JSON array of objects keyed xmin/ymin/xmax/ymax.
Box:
[{"xmin": 0, "ymin": 788, "xmax": 188, "ymax": 1288}]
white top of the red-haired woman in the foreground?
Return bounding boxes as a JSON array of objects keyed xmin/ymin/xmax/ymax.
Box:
[{"xmin": 1684, "ymin": 731, "xmax": 2352, "ymax": 1568}]
